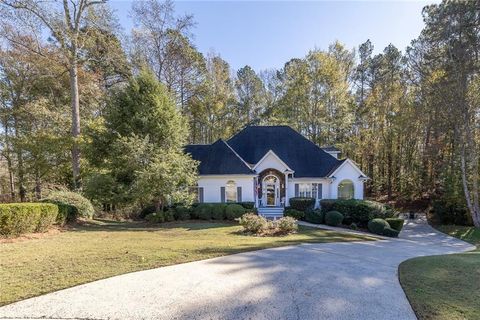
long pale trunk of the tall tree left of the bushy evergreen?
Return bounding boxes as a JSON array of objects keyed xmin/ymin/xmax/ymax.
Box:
[{"xmin": 70, "ymin": 58, "xmax": 80, "ymax": 189}]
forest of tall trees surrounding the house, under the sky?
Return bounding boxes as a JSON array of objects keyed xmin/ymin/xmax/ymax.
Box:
[{"xmin": 0, "ymin": 0, "xmax": 480, "ymax": 226}]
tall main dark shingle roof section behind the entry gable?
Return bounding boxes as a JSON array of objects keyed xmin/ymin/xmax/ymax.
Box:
[{"xmin": 227, "ymin": 126, "xmax": 341, "ymax": 177}]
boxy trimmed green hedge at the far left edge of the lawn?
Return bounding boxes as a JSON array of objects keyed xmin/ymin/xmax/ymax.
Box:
[{"xmin": 0, "ymin": 203, "xmax": 58, "ymax": 237}]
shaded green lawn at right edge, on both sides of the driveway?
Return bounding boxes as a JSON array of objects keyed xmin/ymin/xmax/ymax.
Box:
[{"xmin": 399, "ymin": 226, "xmax": 480, "ymax": 320}]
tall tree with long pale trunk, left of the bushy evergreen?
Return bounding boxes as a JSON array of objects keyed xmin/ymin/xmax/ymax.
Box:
[{"xmin": 1, "ymin": 0, "xmax": 113, "ymax": 187}]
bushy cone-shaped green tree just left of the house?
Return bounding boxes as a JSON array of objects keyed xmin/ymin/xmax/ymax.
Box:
[{"xmin": 86, "ymin": 71, "xmax": 197, "ymax": 209}]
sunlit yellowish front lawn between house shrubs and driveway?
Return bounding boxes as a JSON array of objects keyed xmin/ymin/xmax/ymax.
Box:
[{"xmin": 0, "ymin": 220, "xmax": 375, "ymax": 305}]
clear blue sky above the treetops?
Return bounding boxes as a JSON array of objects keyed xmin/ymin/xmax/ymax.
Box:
[{"xmin": 110, "ymin": 0, "xmax": 432, "ymax": 71}]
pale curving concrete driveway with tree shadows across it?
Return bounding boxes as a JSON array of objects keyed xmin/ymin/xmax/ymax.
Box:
[{"xmin": 0, "ymin": 220, "xmax": 474, "ymax": 320}]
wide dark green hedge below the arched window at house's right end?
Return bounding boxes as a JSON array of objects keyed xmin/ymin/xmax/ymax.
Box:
[{"xmin": 320, "ymin": 199, "xmax": 394, "ymax": 227}]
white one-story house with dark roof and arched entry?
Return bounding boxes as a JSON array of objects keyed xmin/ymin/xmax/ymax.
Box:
[{"xmin": 185, "ymin": 126, "xmax": 367, "ymax": 215}]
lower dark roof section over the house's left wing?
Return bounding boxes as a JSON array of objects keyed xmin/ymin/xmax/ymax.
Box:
[{"xmin": 185, "ymin": 140, "xmax": 254, "ymax": 175}]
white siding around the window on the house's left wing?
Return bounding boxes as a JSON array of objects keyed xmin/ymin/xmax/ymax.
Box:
[{"xmin": 198, "ymin": 175, "xmax": 254, "ymax": 202}]
